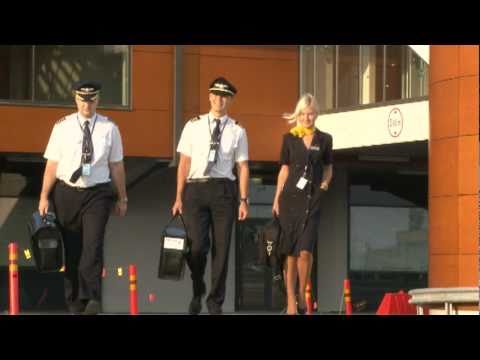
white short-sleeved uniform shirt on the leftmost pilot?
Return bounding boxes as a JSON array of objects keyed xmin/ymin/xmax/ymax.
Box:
[{"xmin": 43, "ymin": 113, "xmax": 123, "ymax": 187}]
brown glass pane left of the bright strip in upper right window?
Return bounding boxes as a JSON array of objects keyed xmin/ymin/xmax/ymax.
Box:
[{"xmin": 338, "ymin": 45, "xmax": 360, "ymax": 107}]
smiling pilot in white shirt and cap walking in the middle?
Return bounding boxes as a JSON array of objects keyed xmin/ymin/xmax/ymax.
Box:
[{"xmin": 172, "ymin": 77, "xmax": 249, "ymax": 314}]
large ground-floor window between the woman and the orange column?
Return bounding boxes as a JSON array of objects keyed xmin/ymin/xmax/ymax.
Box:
[{"xmin": 349, "ymin": 171, "xmax": 428, "ymax": 273}]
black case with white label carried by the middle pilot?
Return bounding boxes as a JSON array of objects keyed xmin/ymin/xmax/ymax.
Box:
[{"xmin": 158, "ymin": 214, "xmax": 190, "ymax": 281}]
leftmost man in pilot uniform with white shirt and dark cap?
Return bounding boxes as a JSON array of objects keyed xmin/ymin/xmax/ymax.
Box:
[{"xmin": 38, "ymin": 81, "xmax": 128, "ymax": 315}]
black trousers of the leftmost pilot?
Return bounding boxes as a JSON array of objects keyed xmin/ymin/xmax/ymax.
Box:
[{"xmin": 51, "ymin": 181, "xmax": 114, "ymax": 304}]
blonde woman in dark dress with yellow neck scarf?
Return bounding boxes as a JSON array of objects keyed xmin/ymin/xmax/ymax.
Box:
[{"xmin": 272, "ymin": 94, "xmax": 333, "ymax": 315}]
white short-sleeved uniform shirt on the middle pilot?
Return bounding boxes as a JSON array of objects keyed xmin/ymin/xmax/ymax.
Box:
[{"xmin": 177, "ymin": 114, "xmax": 248, "ymax": 180}]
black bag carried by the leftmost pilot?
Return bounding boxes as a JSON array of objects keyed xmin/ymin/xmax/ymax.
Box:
[{"xmin": 27, "ymin": 211, "xmax": 65, "ymax": 272}]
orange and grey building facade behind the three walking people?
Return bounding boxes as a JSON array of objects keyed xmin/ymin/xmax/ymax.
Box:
[{"xmin": 0, "ymin": 45, "xmax": 478, "ymax": 313}]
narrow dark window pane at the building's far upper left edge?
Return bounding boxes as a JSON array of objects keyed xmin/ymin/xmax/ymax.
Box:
[{"xmin": 0, "ymin": 46, "xmax": 32, "ymax": 100}]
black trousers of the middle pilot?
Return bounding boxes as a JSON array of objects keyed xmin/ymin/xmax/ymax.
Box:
[{"xmin": 183, "ymin": 179, "xmax": 238, "ymax": 305}]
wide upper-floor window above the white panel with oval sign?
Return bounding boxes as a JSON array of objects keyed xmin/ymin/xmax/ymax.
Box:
[{"xmin": 301, "ymin": 45, "xmax": 429, "ymax": 111}]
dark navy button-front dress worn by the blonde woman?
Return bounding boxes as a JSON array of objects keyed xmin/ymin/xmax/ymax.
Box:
[{"xmin": 279, "ymin": 129, "xmax": 333, "ymax": 256}]
